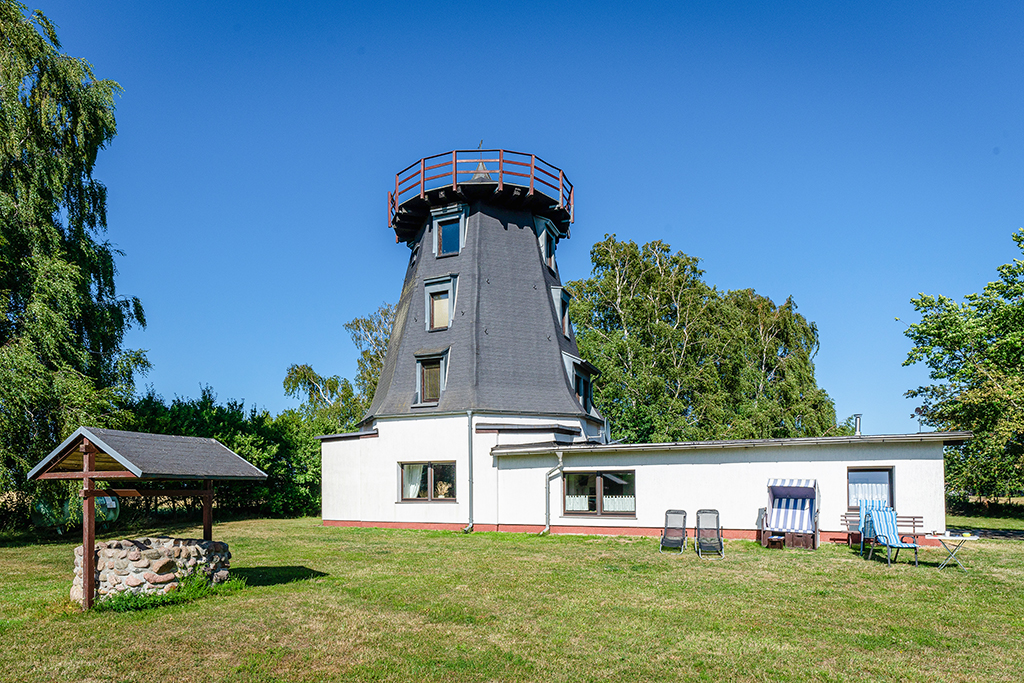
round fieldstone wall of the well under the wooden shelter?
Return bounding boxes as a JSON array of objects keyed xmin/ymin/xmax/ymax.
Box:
[{"xmin": 71, "ymin": 537, "xmax": 231, "ymax": 602}]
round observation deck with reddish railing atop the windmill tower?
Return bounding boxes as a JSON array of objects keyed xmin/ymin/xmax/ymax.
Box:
[{"xmin": 387, "ymin": 150, "xmax": 574, "ymax": 242}]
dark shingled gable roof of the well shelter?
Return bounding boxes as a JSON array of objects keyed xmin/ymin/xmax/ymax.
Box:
[{"xmin": 29, "ymin": 427, "xmax": 266, "ymax": 479}]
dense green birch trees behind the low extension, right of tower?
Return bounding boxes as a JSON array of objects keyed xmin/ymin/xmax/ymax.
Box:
[{"xmin": 569, "ymin": 236, "xmax": 847, "ymax": 442}]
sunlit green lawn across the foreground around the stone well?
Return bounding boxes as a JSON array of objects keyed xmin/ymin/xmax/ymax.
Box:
[{"xmin": 0, "ymin": 519, "xmax": 1024, "ymax": 682}]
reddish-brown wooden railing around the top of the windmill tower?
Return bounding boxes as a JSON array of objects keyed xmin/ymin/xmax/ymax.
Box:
[{"xmin": 387, "ymin": 150, "xmax": 574, "ymax": 227}]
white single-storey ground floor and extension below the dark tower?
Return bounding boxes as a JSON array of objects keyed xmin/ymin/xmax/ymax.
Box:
[{"xmin": 322, "ymin": 414, "xmax": 970, "ymax": 541}]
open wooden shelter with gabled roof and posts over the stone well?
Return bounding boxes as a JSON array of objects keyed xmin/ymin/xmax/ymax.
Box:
[{"xmin": 29, "ymin": 427, "xmax": 266, "ymax": 609}]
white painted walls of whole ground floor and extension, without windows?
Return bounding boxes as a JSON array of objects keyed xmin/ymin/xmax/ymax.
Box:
[{"xmin": 322, "ymin": 414, "xmax": 945, "ymax": 531}]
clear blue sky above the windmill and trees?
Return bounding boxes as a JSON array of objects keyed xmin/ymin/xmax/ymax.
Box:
[{"xmin": 36, "ymin": 0, "xmax": 1024, "ymax": 433}]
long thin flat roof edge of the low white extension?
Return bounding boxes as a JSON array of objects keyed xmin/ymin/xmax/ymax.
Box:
[{"xmin": 490, "ymin": 431, "xmax": 974, "ymax": 457}]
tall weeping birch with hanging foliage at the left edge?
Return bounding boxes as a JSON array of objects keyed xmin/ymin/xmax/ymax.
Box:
[{"xmin": 0, "ymin": 0, "xmax": 147, "ymax": 516}]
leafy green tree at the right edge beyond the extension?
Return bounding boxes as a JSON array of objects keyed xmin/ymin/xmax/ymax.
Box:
[{"xmin": 903, "ymin": 228, "xmax": 1024, "ymax": 496}]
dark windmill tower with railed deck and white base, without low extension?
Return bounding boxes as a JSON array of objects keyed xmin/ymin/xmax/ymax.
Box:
[{"xmin": 322, "ymin": 150, "xmax": 607, "ymax": 527}]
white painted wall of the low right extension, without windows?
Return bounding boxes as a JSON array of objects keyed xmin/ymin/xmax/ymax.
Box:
[{"xmin": 498, "ymin": 442, "xmax": 945, "ymax": 531}]
